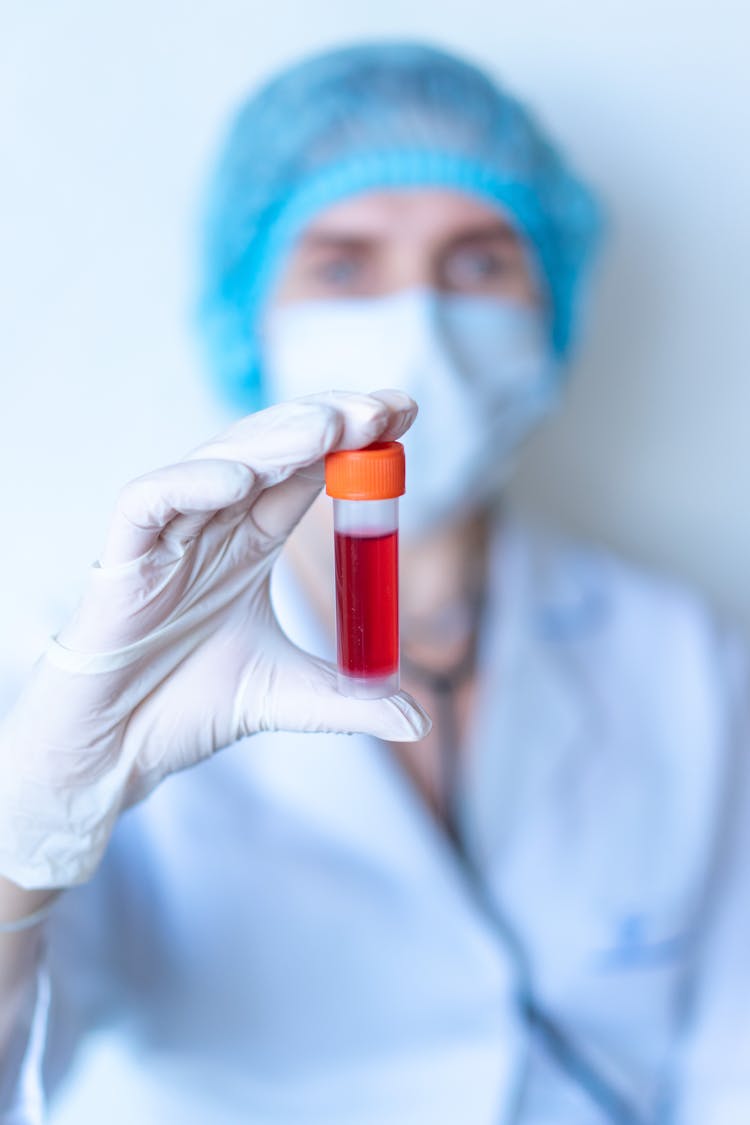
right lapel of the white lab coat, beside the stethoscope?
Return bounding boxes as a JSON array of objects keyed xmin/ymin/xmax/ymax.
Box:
[{"xmin": 459, "ymin": 515, "xmax": 611, "ymax": 866}]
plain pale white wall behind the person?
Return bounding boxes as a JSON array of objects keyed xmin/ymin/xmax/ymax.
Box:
[{"xmin": 0, "ymin": 0, "xmax": 750, "ymax": 702}]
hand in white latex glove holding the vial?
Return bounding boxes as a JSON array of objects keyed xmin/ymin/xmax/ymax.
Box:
[{"xmin": 0, "ymin": 390, "xmax": 430, "ymax": 888}]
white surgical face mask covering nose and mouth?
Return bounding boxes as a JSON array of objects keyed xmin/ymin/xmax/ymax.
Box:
[{"xmin": 263, "ymin": 289, "xmax": 560, "ymax": 537}]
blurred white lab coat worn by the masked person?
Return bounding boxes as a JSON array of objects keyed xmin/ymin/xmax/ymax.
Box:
[{"xmin": 0, "ymin": 523, "xmax": 750, "ymax": 1125}]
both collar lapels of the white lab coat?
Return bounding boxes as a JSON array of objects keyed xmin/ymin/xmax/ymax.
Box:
[{"xmin": 268, "ymin": 511, "xmax": 607, "ymax": 886}]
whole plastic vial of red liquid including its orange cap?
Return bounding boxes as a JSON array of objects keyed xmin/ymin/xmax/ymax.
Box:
[{"xmin": 326, "ymin": 441, "xmax": 405, "ymax": 699}]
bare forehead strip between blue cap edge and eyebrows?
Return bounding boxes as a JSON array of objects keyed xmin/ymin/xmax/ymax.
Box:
[{"xmin": 301, "ymin": 188, "xmax": 513, "ymax": 242}]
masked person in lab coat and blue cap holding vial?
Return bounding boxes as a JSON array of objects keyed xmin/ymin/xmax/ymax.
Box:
[{"xmin": 0, "ymin": 43, "xmax": 750, "ymax": 1125}]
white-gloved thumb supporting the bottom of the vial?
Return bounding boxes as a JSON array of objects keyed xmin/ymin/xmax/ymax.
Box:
[{"xmin": 235, "ymin": 649, "xmax": 432, "ymax": 743}]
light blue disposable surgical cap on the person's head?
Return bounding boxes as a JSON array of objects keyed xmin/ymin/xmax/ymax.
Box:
[{"xmin": 199, "ymin": 43, "xmax": 599, "ymax": 411}]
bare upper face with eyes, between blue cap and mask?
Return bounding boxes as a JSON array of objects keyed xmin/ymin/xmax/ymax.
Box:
[{"xmin": 272, "ymin": 188, "xmax": 542, "ymax": 305}]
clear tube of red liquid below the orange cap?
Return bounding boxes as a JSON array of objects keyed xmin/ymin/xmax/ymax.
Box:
[{"xmin": 333, "ymin": 497, "xmax": 399, "ymax": 699}]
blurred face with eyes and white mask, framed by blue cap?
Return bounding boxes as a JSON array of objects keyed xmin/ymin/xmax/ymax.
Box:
[{"xmin": 262, "ymin": 189, "xmax": 553, "ymax": 539}]
